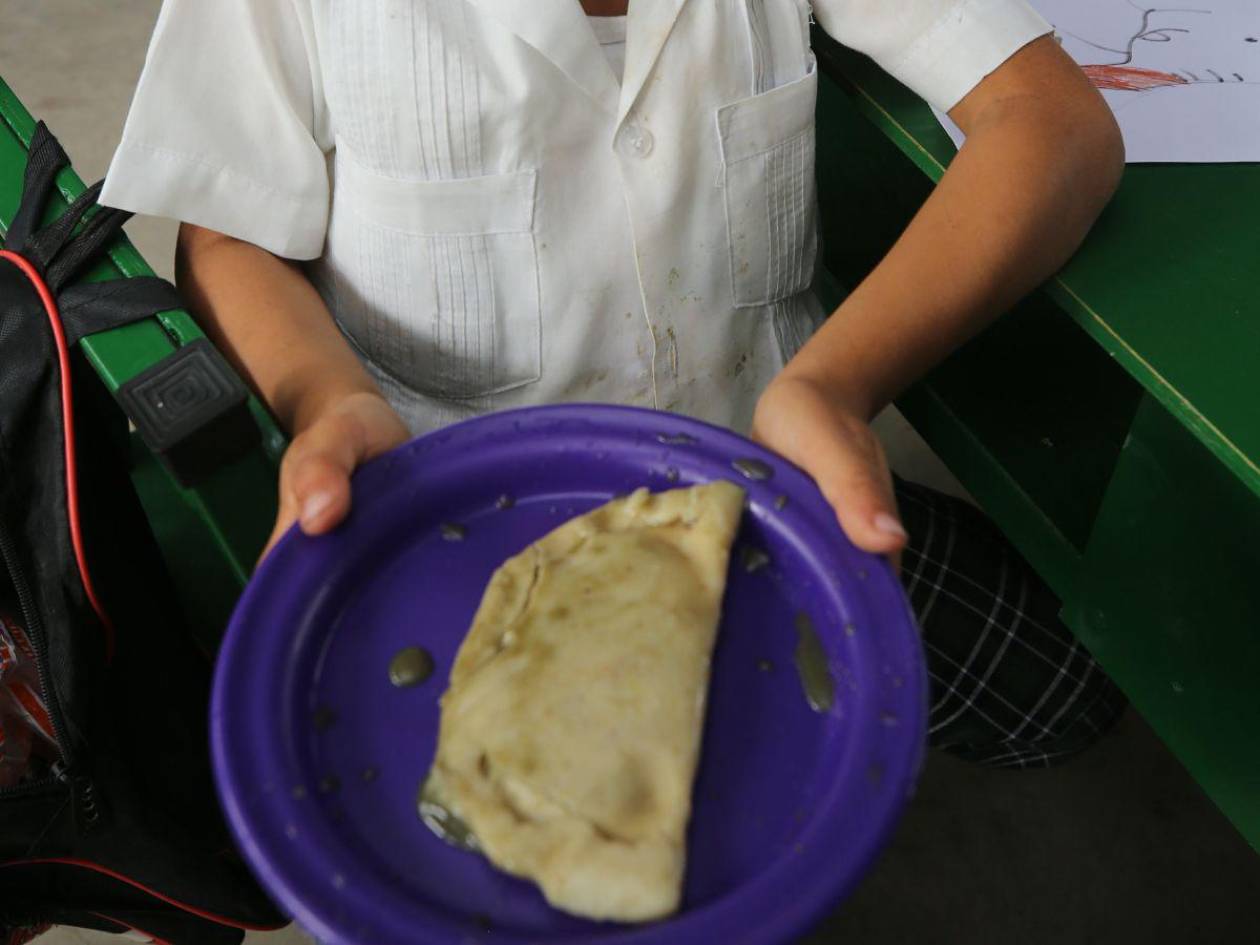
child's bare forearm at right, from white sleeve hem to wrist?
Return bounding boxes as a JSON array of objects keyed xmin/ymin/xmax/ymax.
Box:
[{"xmin": 788, "ymin": 38, "xmax": 1124, "ymax": 418}]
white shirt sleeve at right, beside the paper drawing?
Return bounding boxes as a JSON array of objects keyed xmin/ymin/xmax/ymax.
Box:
[{"xmin": 814, "ymin": 0, "xmax": 1053, "ymax": 111}]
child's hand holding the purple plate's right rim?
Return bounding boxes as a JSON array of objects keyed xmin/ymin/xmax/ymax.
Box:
[{"xmin": 752, "ymin": 372, "xmax": 906, "ymax": 564}]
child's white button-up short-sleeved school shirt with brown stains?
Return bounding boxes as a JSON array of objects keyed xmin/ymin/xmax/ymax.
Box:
[{"xmin": 101, "ymin": 0, "xmax": 1050, "ymax": 432}]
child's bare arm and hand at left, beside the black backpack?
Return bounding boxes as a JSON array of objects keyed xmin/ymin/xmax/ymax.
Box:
[{"xmin": 175, "ymin": 224, "xmax": 408, "ymax": 548}]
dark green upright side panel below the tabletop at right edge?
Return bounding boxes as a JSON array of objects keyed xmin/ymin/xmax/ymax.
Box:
[{"xmin": 1063, "ymin": 397, "xmax": 1260, "ymax": 851}]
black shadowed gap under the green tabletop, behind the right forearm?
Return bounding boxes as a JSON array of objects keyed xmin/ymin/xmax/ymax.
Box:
[{"xmin": 818, "ymin": 76, "xmax": 1140, "ymax": 587}]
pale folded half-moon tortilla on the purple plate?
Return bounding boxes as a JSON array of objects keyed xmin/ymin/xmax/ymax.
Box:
[{"xmin": 425, "ymin": 481, "xmax": 743, "ymax": 921}]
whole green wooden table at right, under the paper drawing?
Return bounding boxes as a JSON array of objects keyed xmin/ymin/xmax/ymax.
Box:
[{"xmin": 815, "ymin": 33, "xmax": 1260, "ymax": 849}]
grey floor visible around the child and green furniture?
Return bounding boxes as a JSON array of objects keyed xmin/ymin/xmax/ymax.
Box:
[{"xmin": 0, "ymin": 0, "xmax": 1260, "ymax": 945}]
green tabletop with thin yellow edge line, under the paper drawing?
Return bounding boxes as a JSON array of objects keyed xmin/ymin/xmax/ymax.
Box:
[{"xmin": 815, "ymin": 32, "xmax": 1260, "ymax": 504}]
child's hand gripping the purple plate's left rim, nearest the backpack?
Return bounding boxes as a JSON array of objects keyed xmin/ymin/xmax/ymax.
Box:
[{"xmin": 262, "ymin": 392, "xmax": 411, "ymax": 557}]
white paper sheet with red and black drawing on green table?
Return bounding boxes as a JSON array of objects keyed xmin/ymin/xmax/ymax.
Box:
[{"xmin": 936, "ymin": 0, "xmax": 1260, "ymax": 164}]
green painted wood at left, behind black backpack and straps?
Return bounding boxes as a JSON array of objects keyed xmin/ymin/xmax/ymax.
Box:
[{"xmin": 0, "ymin": 79, "xmax": 285, "ymax": 629}]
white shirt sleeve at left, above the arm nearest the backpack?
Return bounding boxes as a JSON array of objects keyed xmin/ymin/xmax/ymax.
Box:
[{"xmin": 101, "ymin": 0, "xmax": 331, "ymax": 260}]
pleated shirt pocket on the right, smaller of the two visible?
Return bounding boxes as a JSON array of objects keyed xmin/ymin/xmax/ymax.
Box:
[{"xmin": 717, "ymin": 59, "xmax": 818, "ymax": 307}]
